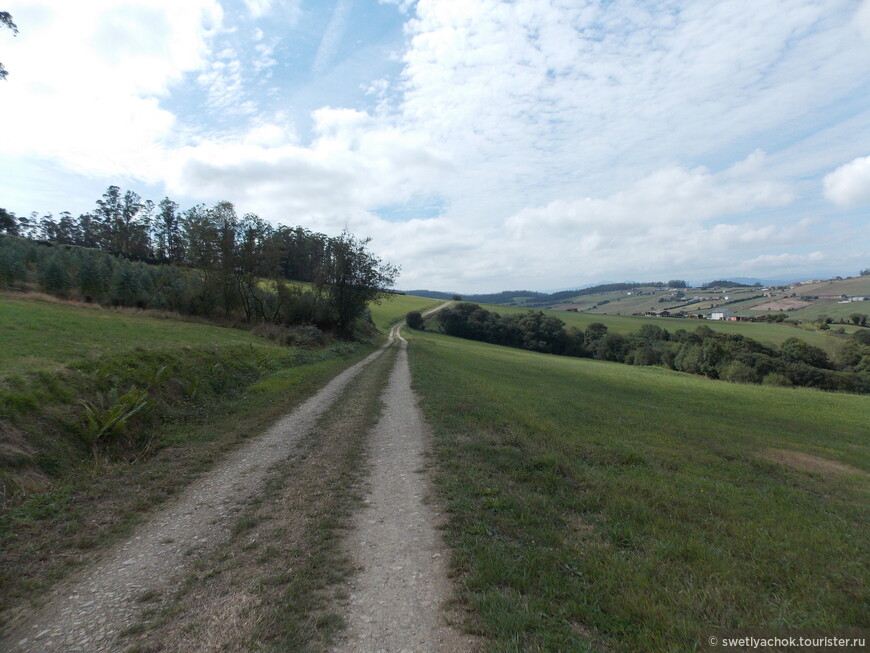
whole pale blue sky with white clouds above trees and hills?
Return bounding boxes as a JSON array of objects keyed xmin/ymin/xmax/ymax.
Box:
[{"xmin": 0, "ymin": 0, "xmax": 870, "ymax": 293}]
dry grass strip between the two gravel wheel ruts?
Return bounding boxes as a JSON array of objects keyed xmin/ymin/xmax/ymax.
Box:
[{"xmin": 122, "ymin": 347, "xmax": 397, "ymax": 651}]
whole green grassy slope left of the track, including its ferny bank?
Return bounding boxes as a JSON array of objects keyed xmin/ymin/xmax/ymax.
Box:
[{"xmin": 0, "ymin": 296, "xmax": 376, "ymax": 612}]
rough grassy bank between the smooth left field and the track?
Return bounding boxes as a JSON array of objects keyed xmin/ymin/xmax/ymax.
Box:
[{"xmin": 0, "ymin": 344, "xmax": 372, "ymax": 624}]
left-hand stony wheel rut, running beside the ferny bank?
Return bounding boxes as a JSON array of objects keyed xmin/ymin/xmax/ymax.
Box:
[{"xmin": 0, "ymin": 348, "xmax": 384, "ymax": 653}]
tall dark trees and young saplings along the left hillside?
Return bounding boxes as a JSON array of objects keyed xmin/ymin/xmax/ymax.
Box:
[{"xmin": 0, "ymin": 186, "xmax": 398, "ymax": 335}]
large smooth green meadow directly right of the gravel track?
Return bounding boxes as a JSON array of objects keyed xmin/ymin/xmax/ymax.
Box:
[{"xmin": 410, "ymin": 332, "xmax": 870, "ymax": 651}]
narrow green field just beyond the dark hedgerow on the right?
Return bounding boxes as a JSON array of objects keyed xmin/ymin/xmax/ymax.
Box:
[{"xmin": 483, "ymin": 304, "xmax": 842, "ymax": 353}]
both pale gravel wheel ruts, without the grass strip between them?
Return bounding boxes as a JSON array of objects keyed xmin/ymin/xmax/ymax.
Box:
[{"xmin": 0, "ymin": 306, "xmax": 472, "ymax": 652}]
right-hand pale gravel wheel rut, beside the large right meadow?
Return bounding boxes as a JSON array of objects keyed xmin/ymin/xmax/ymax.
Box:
[{"xmin": 334, "ymin": 327, "xmax": 474, "ymax": 653}]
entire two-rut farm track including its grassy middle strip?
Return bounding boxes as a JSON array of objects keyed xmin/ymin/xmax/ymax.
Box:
[{"xmin": 0, "ymin": 306, "xmax": 473, "ymax": 651}]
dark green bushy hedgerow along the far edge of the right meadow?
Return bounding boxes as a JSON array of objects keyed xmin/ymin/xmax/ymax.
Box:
[{"xmin": 418, "ymin": 303, "xmax": 870, "ymax": 393}]
